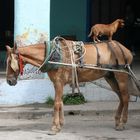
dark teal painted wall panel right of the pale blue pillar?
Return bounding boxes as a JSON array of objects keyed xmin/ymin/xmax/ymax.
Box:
[{"xmin": 50, "ymin": 0, "xmax": 87, "ymax": 41}]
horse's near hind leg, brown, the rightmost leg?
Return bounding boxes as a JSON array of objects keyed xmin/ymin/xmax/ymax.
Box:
[{"xmin": 116, "ymin": 73, "xmax": 129, "ymax": 131}]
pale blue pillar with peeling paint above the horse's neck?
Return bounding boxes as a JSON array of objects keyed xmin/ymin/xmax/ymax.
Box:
[{"xmin": 14, "ymin": 0, "xmax": 50, "ymax": 45}]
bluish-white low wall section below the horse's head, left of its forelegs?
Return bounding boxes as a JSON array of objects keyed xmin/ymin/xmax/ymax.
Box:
[{"xmin": 0, "ymin": 79, "xmax": 54, "ymax": 105}]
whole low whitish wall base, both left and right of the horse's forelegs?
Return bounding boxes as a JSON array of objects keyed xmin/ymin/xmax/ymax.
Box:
[{"xmin": 0, "ymin": 76, "xmax": 118, "ymax": 105}]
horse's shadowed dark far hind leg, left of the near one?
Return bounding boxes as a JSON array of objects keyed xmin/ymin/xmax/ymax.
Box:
[{"xmin": 105, "ymin": 72, "xmax": 123, "ymax": 128}]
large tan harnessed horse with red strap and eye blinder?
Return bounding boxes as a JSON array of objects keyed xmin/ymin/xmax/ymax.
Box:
[{"xmin": 6, "ymin": 37, "xmax": 133, "ymax": 134}]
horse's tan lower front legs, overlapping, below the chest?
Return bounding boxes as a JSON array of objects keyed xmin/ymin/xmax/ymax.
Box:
[{"xmin": 52, "ymin": 81, "xmax": 64, "ymax": 132}]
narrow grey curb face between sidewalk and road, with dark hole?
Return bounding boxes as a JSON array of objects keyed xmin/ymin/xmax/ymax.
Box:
[{"xmin": 0, "ymin": 108, "xmax": 140, "ymax": 119}]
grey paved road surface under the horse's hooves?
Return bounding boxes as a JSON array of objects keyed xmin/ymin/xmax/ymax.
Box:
[{"xmin": 0, "ymin": 114, "xmax": 140, "ymax": 140}]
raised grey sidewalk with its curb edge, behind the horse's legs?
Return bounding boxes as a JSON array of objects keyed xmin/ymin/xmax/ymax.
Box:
[{"xmin": 0, "ymin": 101, "xmax": 140, "ymax": 119}]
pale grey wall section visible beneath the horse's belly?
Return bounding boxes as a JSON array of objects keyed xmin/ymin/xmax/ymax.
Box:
[{"xmin": 64, "ymin": 79, "xmax": 118, "ymax": 101}]
